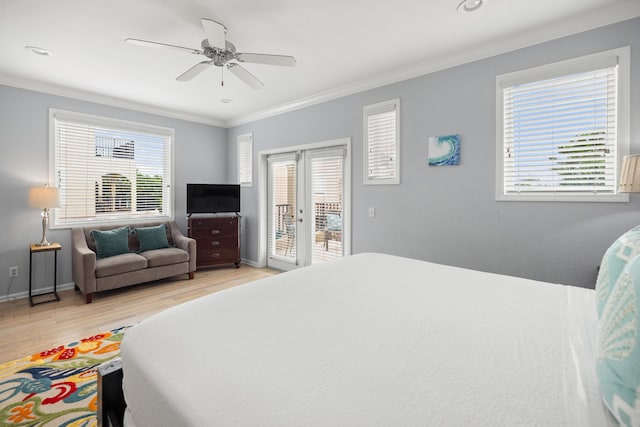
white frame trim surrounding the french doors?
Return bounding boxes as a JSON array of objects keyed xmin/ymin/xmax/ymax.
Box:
[{"xmin": 257, "ymin": 138, "xmax": 351, "ymax": 267}]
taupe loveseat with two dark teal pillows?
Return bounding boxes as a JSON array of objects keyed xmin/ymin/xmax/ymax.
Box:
[{"xmin": 71, "ymin": 221, "xmax": 196, "ymax": 303}]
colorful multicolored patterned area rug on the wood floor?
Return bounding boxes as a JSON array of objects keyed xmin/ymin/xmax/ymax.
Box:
[{"xmin": 0, "ymin": 326, "xmax": 129, "ymax": 427}]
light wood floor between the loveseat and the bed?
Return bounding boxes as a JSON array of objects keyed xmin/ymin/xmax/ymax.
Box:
[{"xmin": 0, "ymin": 264, "xmax": 278, "ymax": 363}]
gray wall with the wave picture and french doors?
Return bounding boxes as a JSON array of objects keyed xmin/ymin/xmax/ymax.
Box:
[{"xmin": 228, "ymin": 19, "xmax": 640, "ymax": 287}]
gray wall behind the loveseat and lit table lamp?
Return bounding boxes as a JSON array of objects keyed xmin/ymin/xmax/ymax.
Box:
[{"xmin": 0, "ymin": 85, "xmax": 227, "ymax": 300}]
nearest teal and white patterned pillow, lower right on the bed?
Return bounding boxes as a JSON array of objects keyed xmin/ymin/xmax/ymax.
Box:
[{"xmin": 596, "ymin": 256, "xmax": 640, "ymax": 426}]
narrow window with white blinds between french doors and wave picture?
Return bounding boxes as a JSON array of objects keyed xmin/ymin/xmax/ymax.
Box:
[{"xmin": 364, "ymin": 99, "xmax": 400, "ymax": 184}]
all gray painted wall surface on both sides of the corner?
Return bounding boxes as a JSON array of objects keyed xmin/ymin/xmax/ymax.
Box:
[{"xmin": 0, "ymin": 19, "xmax": 640, "ymax": 299}]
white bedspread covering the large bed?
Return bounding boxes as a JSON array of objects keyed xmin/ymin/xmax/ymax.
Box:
[{"xmin": 122, "ymin": 254, "xmax": 607, "ymax": 427}]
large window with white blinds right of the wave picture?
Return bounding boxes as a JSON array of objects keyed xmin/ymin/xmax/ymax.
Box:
[{"xmin": 496, "ymin": 48, "xmax": 629, "ymax": 201}]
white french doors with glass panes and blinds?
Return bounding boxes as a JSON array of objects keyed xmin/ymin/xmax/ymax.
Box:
[{"xmin": 267, "ymin": 146, "xmax": 350, "ymax": 270}]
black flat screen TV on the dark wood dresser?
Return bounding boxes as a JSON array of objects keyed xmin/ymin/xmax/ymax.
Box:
[{"xmin": 187, "ymin": 184, "xmax": 240, "ymax": 215}]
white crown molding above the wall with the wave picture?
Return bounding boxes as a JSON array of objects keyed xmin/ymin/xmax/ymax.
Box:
[{"xmin": 226, "ymin": 0, "xmax": 640, "ymax": 127}]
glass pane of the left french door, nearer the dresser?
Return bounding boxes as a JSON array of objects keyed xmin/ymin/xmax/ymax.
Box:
[{"xmin": 269, "ymin": 160, "xmax": 297, "ymax": 263}]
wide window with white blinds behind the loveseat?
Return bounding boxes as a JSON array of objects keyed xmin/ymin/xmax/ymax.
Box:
[{"xmin": 49, "ymin": 109, "xmax": 174, "ymax": 227}]
